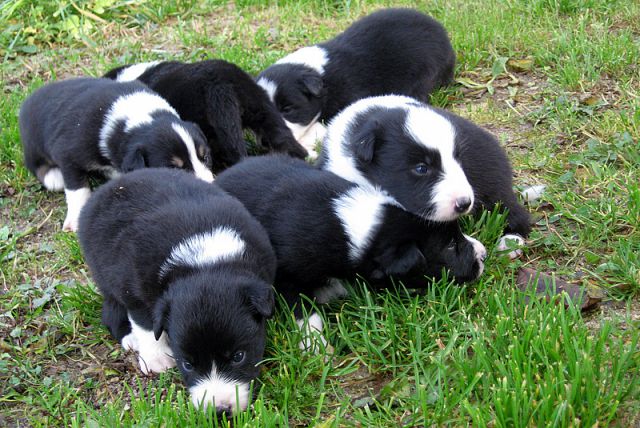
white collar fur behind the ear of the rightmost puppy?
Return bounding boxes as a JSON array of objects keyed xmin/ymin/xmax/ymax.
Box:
[{"xmin": 322, "ymin": 95, "xmax": 417, "ymax": 184}]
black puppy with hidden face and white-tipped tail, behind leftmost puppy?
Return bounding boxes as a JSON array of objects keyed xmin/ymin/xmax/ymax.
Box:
[{"xmin": 105, "ymin": 60, "xmax": 307, "ymax": 171}]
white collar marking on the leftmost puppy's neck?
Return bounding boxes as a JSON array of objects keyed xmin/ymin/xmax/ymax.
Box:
[{"xmin": 98, "ymin": 91, "xmax": 179, "ymax": 159}]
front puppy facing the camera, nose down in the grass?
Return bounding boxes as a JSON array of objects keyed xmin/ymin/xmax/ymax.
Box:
[{"xmin": 78, "ymin": 168, "xmax": 276, "ymax": 413}]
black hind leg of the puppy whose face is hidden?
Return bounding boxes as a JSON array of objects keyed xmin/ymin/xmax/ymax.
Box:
[{"xmin": 205, "ymin": 85, "xmax": 247, "ymax": 166}]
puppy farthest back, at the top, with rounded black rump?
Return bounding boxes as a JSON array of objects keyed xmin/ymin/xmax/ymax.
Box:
[{"xmin": 258, "ymin": 9, "xmax": 456, "ymax": 153}]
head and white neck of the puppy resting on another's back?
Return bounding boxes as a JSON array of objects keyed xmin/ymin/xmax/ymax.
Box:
[{"xmin": 321, "ymin": 96, "xmax": 474, "ymax": 221}]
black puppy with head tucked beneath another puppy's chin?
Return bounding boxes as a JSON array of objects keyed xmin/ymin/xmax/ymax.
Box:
[{"xmin": 216, "ymin": 156, "xmax": 486, "ymax": 348}]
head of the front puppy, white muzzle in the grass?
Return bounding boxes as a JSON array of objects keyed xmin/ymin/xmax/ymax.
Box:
[{"xmin": 154, "ymin": 268, "xmax": 274, "ymax": 414}]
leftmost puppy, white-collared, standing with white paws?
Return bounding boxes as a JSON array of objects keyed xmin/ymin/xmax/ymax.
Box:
[{"xmin": 19, "ymin": 78, "xmax": 213, "ymax": 231}]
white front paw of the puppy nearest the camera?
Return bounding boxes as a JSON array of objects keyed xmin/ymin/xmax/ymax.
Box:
[{"xmin": 121, "ymin": 314, "xmax": 176, "ymax": 375}]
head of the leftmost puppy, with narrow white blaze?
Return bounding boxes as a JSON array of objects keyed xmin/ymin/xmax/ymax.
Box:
[{"xmin": 121, "ymin": 115, "xmax": 213, "ymax": 182}]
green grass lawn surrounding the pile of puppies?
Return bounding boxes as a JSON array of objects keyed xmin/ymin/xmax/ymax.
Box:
[{"xmin": 0, "ymin": 0, "xmax": 640, "ymax": 427}]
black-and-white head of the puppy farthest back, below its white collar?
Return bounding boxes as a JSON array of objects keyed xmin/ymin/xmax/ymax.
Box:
[{"xmin": 257, "ymin": 63, "xmax": 325, "ymax": 141}]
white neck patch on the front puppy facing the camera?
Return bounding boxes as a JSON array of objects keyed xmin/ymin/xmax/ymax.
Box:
[{"xmin": 159, "ymin": 226, "xmax": 246, "ymax": 278}]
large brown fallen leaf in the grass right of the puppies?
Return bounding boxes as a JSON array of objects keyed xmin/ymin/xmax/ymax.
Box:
[{"xmin": 516, "ymin": 268, "xmax": 602, "ymax": 311}]
